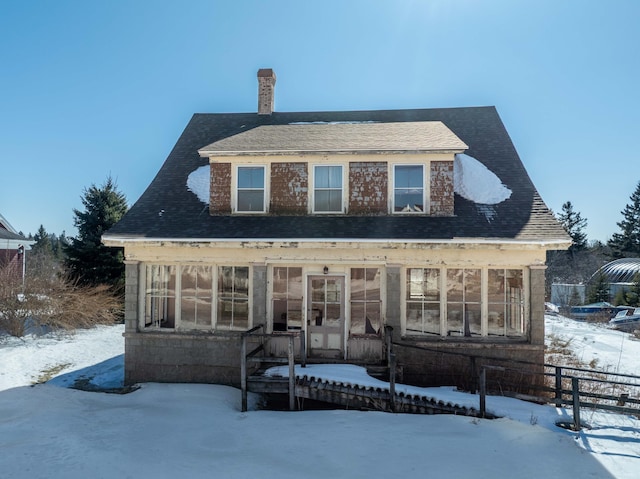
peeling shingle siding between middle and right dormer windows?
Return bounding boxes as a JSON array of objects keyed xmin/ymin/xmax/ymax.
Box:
[{"xmin": 349, "ymin": 161, "xmax": 388, "ymax": 215}]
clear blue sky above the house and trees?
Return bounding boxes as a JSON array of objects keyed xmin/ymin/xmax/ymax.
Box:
[{"xmin": 0, "ymin": 0, "xmax": 640, "ymax": 241}]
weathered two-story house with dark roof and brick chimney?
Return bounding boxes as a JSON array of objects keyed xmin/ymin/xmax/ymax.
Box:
[{"xmin": 103, "ymin": 69, "xmax": 570, "ymax": 384}]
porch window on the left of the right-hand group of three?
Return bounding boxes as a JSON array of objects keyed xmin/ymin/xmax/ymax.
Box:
[{"xmin": 406, "ymin": 268, "xmax": 441, "ymax": 335}]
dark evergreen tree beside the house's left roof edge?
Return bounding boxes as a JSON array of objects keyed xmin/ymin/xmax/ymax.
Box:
[{"xmin": 63, "ymin": 177, "xmax": 128, "ymax": 288}]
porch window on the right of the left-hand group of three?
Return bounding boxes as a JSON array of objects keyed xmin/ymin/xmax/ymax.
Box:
[{"xmin": 216, "ymin": 266, "xmax": 249, "ymax": 330}]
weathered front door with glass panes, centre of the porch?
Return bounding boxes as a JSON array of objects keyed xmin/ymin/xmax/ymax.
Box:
[{"xmin": 307, "ymin": 276, "xmax": 344, "ymax": 359}]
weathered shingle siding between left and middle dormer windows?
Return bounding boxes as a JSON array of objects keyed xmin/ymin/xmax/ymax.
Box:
[{"xmin": 269, "ymin": 163, "xmax": 309, "ymax": 215}]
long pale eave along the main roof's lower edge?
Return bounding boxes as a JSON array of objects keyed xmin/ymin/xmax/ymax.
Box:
[{"xmin": 102, "ymin": 235, "xmax": 571, "ymax": 250}]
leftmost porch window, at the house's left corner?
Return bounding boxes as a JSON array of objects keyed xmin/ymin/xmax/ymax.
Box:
[{"xmin": 144, "ymin": 264, "xmax": 176, "ymax": 329}]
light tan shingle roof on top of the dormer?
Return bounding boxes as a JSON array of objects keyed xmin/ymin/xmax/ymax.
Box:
[{"xmin": 200, "ymin": 121, "xmax": 467, "ymax": 156}]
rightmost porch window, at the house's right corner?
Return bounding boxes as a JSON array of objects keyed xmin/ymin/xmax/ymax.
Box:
[{"xmin": 487, "ymin": 269, "xmax": 525, "ymax": 336}]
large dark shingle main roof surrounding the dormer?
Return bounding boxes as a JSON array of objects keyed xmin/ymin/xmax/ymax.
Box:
[{"xmin": 105, "ymin": 107, "xmax": 569, "ymax": 246}]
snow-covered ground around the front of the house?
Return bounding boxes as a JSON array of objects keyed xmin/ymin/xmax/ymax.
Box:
[{"xmin": 0, "ymin": 316, "xmax": 640, "ymax": 478}]
